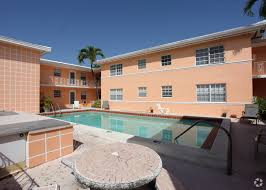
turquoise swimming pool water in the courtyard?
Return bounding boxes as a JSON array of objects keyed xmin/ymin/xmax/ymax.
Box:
[{"xmin": 51, "ymin": 112, "xmax": 217, "ymax": 148}]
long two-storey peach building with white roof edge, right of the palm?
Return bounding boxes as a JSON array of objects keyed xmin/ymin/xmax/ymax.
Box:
[{"xmin": 98, "ymin": 21, "xmax": 266, "ymax": 116}]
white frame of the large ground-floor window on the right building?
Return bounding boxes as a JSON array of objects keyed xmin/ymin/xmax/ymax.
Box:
[{"xmin": 196, "ymin": 83, "xmax": 227, "ymax": 103}]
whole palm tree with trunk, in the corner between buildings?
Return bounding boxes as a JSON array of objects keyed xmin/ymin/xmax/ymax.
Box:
[{"xmin": 78, "ymin": 46, "xmax": 104, "ymax": 100}]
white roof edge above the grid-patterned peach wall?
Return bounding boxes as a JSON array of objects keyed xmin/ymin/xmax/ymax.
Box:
[{"xmin": 0, "ymin": 36, "xmax": 52, "ymax": 53}]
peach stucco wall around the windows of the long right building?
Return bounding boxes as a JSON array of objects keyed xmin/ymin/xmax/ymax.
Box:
[{"xmin": 101, "ymin": 35, "xmax": 252, "ymax": 116}]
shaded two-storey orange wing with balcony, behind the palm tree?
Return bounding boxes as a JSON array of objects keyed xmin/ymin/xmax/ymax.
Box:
[{"xmin": 40, "ymin": 59, "xmax": 98, "ymax": 109}]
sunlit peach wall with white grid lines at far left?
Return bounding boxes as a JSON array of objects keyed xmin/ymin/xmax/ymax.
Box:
[{"xmin": 0, "ymin": 42, "xmax": 41, "ymax": 113}]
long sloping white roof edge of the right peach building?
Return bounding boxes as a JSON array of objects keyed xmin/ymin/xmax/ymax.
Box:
[{"xmin": 97, "ymin": 20, "xmax": 266, "ymax": 64}]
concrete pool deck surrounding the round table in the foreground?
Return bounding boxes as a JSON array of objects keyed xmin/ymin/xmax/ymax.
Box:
[{"xmin": 0, "ymin": 119, "xmax": 266, "ymax": 190}]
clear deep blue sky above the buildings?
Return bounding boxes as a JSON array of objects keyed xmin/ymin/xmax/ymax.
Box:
[{"xmin": 0, "ymin": 0, "xmax": 259, "ymax": 63}]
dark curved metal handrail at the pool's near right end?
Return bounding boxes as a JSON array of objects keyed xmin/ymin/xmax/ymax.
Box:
[{"xmin": 174, "ymin": 120, "xmax": 233, "ymax": 175}]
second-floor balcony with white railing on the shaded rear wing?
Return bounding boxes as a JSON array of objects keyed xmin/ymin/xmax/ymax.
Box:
[{"xmin": 41, "ymin": 76, "xmax": 101, "ymax": 88}]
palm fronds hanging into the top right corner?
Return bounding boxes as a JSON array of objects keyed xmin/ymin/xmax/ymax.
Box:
[{"xmin": 244, "ymin": 0, "xmax": 266, "ymax": 19}]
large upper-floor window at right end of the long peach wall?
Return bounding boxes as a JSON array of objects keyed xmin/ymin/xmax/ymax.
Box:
[{"xmin": 196, "ymin": 46, "xmax": 224, "ymax": 65}]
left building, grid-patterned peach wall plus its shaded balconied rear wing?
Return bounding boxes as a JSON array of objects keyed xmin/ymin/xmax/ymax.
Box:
[{"xmin": 0, "ymin": 36, "xmax": 101, "ymax": 113}]
